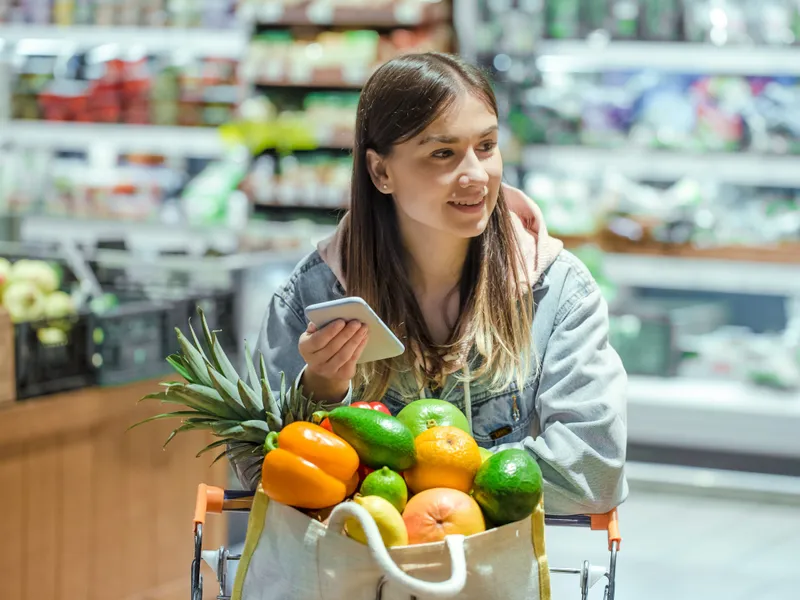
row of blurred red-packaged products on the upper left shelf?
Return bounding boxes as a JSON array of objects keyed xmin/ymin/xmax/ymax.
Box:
[{"xmin": 11, "ymin": 40, "xmax": 239, "ymax": 127}]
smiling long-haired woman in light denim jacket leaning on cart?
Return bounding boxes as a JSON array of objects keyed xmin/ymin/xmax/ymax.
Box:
[{"xmin": 240, "ymin": 53, "xmax": 627, "ymax": 513}]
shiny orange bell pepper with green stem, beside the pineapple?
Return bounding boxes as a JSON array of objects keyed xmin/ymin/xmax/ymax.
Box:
[{"xmin": 261, "ymin": 421, "xmax": 359, "ymax": 509}]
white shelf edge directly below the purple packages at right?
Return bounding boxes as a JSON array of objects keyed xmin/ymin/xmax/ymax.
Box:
[{"xmin": 522, "ymin": 145, "xmax": 800, "ymax": 187}]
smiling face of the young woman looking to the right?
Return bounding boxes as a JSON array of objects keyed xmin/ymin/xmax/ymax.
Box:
[{"xmin": 369, "ymin": 94, "xmax": 503, "ymax": 239}]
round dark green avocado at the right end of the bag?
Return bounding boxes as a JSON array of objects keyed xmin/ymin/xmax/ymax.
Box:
[{"xmin": 472, "ymin": 448, "xmax": 542, "ymax": 526}]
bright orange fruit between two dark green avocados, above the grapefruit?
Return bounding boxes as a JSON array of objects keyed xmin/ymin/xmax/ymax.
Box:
[{"xmin": 405, "ymin": 426, "xmax": 481, "ymax": 494}]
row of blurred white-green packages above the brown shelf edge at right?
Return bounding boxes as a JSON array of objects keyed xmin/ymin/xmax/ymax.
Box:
[{"xmin": 523, "ymin": 173, "xmax": 800, "ymax": 264}]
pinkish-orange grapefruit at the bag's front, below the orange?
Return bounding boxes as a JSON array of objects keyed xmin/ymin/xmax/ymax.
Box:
[{"xmin": 403, "ymin": 488, "xmax": 486, "ymax": 544}]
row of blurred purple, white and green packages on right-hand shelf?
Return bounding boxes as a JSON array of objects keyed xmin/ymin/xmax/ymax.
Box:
[{"xmin": 501, "ymin": 71, "xmax": 800, "ymax": 154}]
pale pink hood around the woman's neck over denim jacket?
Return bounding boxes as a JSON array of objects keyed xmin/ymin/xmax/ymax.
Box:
[{"xmin": 317, "ymin": 184, "xmax": 564, "ymax": 289}]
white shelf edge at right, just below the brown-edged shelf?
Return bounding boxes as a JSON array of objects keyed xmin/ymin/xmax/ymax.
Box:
[{"xmin": 603, "ymin": 254, "xmax": 800, "ymax": 297}]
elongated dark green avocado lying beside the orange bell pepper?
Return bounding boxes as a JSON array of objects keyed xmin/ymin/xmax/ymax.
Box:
[{"xmin": 328, "ymin": 406, "xmax": 417, "ymax": 471}]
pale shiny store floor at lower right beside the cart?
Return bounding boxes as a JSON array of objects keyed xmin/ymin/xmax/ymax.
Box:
[{"xmin": 547, "ymin": 491, "xmax": 800, "ymax": 600}]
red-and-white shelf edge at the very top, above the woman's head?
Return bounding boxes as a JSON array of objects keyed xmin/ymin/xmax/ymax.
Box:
[{"xmin": 239, "ymin": 0, "xmax": 450, "ymax": 27}]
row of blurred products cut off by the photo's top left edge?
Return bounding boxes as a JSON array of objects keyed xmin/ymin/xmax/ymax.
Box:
[{"xmin": 0, "ymin": 0, "xmax": 238, "ymax": 29}]
